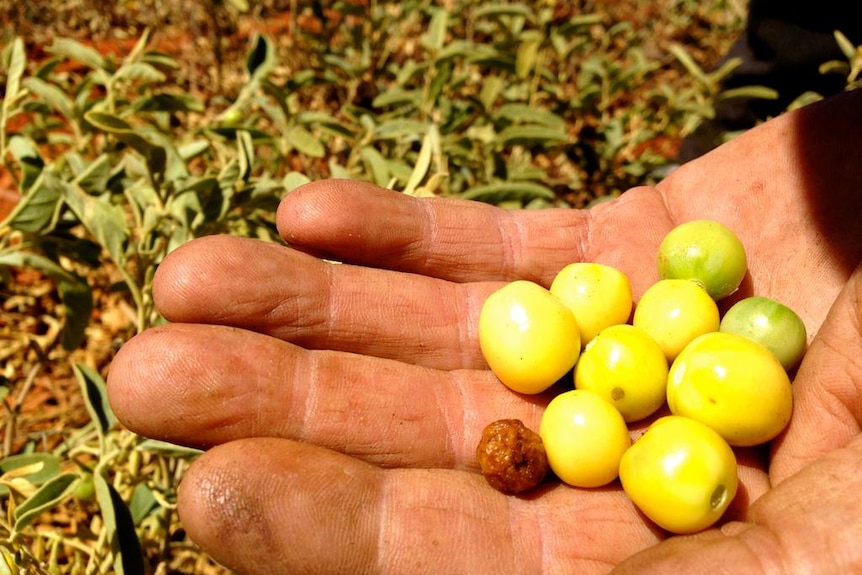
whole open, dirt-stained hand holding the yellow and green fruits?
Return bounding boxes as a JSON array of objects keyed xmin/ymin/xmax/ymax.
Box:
[{"xmin": 103, "ymin": 93, "xmax": 862, "ymax": 575}]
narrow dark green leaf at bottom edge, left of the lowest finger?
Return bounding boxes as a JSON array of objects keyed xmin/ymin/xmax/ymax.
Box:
[{"xmin": 93, "ymin": 465, "xmax": 146, "ymax": 575}]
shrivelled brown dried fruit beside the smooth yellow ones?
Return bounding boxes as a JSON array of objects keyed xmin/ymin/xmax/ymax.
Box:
[{"xmin": 476, "ymin": 419, "xmax": 548, "ymax": 494}]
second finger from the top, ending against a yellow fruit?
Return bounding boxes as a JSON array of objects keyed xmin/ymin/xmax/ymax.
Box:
[{"xmin": 154, "ymin": 236, "xmax": 497, "ymax": 369}]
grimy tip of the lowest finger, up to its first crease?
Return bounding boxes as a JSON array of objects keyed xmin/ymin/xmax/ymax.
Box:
[{"xmin": 179, "ymin": 439, "xmax": 380, "ymax": 575}]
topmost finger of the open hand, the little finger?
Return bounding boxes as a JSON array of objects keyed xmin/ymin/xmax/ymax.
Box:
[{"xmin": 277, "ymin": 180, "xmax": 671, "ymax": 291}]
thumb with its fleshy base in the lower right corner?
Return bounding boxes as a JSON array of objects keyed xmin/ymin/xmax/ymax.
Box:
[{"xmin": 618, "ymin": 266, "xmax": 862, "ymax": 575}]
